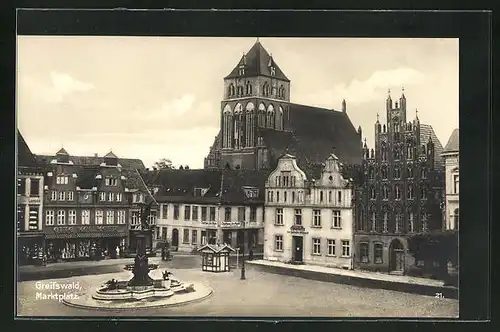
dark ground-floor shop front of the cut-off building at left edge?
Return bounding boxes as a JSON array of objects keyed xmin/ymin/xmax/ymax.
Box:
[{"xmin": 17, "ymin": 232, "xmax": 45, "ymax": 265}]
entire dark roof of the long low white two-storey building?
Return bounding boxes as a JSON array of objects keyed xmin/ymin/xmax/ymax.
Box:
[{"xmin": 142, "ymin": 169, "xmax": 269, "ymax": 204}]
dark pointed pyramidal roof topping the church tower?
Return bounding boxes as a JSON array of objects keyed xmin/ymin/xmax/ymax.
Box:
[{"xmin": 225, "ymin": 41, "xmax": 290, "ymax": 82}]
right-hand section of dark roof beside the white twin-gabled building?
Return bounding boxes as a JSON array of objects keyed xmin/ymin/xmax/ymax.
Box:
[{"xmin": 221, "ymin": 169, "xmax": 270, "ymax": 204}]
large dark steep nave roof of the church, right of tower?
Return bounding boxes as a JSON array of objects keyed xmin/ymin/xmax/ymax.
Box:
[{"xmin": 259, "ymin": 104, "xmax": 362, "ymax": 173}]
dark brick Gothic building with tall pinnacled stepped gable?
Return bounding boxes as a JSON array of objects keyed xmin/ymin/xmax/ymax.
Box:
[{"xmin": 355, "ymin": 89, "xmax": 443, "ymax": 273}]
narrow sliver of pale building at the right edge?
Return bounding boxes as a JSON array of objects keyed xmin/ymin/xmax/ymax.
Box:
[{"xmin": 442, "ymin": 129, "xmax": 460, "ymax": 230}]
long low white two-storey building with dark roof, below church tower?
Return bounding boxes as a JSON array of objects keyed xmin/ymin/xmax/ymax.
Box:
[{"xmin": 143, "ymin": 169, "xmax": 267, "ymax": 252}]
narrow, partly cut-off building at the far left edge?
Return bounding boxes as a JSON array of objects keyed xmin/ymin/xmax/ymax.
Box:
[{"xmin": 16, "ymin": 132, "xmax": 45, "ymax": 264}]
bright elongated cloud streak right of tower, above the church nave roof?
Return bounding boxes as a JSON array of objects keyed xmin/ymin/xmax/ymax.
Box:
[{"xmin": 301, "ymin": 68, "xmax": 424, "ymax": 108}]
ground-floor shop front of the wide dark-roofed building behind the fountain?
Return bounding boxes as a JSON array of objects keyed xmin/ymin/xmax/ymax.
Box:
[{"xmin": 45, "ymin": 225, "xmax": 128, "ymax": 262}]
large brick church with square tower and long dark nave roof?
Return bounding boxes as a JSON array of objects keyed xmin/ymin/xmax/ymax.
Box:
[{"xmin": 205, "ymin": 41, "xmax": 361, "ymax": 170}]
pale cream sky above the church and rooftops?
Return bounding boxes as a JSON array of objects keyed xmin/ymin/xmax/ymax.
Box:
[{"xmin": 16, "ymin": 36, "xmax": 459, "ymax": 168}]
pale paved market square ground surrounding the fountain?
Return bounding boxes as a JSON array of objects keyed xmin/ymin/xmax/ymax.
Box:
[{"xmin": 18, "ymin": 257, "xmax": 458, "ymax": 318}]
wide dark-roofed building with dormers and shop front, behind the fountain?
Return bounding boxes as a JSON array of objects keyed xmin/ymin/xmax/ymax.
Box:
[{"xmin": 43, "ymin": 149, "xmax": 157, "ymax": 260}]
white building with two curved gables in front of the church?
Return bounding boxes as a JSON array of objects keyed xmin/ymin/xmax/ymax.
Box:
[{"xmin": 264, "ymin": 154, "xmax": 354, "ymax": 269}]
